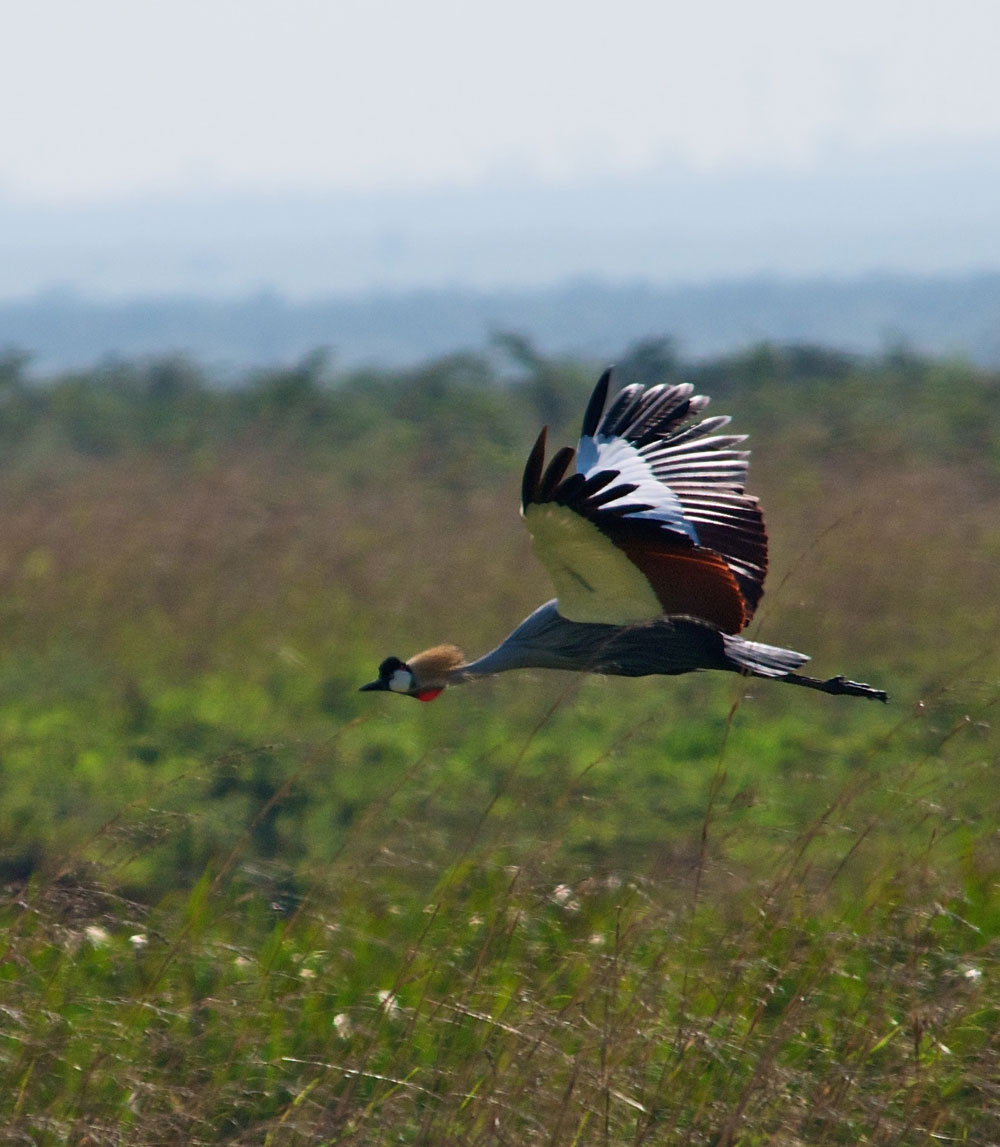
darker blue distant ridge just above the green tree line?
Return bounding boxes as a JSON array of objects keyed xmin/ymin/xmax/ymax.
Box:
[{"xmin": 7, "ymin": 272, "xmax": 1000, "ymax": 381}]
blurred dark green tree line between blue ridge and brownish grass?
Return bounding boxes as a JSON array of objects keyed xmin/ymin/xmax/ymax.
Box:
[{"xmin": 0, "ymin": 333, "xmax": 1000, "ymax": 479}]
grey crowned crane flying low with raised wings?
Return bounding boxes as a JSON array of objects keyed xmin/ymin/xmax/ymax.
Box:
[{"xmin": 361, "ymin": 370, "xmax": 888, "ymax": 701}]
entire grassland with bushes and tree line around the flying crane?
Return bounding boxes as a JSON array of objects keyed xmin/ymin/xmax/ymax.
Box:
[{"xmin": 0, "ymin": 335, "xmax": 1000, "ymax": 1145}]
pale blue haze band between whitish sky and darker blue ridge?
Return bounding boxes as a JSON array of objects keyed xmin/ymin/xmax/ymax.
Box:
[{"xmin": 0, "ymin": 133, "xmax": 1000, "ymax": 299}]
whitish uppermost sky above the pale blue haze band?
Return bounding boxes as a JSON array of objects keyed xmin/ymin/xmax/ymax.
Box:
[{"xmin": 0, "ymin": 0, "xmax": 1000, "ymax": 204}]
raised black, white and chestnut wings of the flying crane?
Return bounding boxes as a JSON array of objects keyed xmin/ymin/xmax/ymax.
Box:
[{"xmin": 522, "ymin": 370, "xmax": 767, "ymax": 633}]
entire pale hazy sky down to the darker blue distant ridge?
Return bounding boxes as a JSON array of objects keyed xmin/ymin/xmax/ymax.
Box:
[{"xmin": 0, "ymin": 0, "xmax": 1000, "ymax": 299}]
